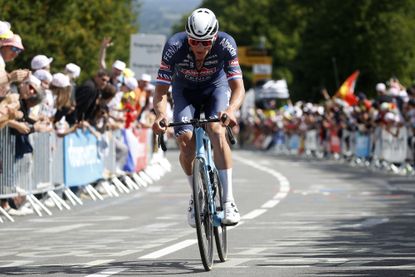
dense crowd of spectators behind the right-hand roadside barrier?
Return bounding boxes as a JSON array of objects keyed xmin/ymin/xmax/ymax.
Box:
[{"xmin": 240, "ymin": 77, "xmax": 415, "ymax": 166}]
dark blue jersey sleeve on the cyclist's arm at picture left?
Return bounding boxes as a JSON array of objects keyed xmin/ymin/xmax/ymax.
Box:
[{"xmin": 156, "ymin": 37, "xmax": 181, "ymax": 85}]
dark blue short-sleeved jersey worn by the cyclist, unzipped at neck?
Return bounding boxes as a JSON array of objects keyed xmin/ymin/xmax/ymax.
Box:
[{"xmin": 157, "ymin": 32, "xmax": 242, "ymax": 88}]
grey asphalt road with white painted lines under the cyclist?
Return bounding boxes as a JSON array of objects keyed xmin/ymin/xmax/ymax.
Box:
[{"xmin": 0, "ymin": 150, "xmax": 415, "ymax": 277}]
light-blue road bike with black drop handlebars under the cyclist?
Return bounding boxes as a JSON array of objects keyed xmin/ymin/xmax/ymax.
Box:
[{"xmin": 159, "ymin": 116, "xmax": 236, "ymax": 271}]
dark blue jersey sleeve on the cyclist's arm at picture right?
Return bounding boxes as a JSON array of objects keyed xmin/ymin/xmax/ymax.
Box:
[{"xmin": 220, "ymin": 36, "xmax": 242, "ymax": 81}]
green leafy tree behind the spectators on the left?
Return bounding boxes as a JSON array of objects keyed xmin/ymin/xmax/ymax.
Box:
[{"xmin": 0, "ymin": 0, "xmax": 138, "ymax": 79}]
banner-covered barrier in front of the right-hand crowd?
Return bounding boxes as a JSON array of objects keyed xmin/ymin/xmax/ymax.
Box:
[{"xmin": 274, "ymin": 126, "xmax": 415, "ymax": 175}]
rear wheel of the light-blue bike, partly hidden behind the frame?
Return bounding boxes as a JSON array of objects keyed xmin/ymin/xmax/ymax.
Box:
[{"xmin": 212, "ymin": 170, "xmax": 228, "ymax": 262}]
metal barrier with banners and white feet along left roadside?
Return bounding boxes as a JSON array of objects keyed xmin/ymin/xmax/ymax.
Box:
[{"xmin": 0, "ymin": 128, "xmax": 170, "ymax": 222}]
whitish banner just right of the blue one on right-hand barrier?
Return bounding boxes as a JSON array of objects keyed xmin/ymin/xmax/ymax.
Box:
[{"xmin": 381, "ymin": 127, "xmax": 408, "ymax": 163}]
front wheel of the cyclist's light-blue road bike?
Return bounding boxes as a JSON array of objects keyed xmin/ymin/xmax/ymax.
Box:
[{"xmin": 193, "ymin": 159, "xmax": 214, "ymax": 271}]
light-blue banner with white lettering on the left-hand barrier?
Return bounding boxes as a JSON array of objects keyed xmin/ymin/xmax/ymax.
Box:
[{"xmin": 63, "ymin": 129, "xmax": 104, "ymax": 186}]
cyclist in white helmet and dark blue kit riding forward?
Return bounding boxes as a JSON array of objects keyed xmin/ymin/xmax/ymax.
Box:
[{"xmin": 153, "ymin": 8, "xmax": 245, "ymax": 227}]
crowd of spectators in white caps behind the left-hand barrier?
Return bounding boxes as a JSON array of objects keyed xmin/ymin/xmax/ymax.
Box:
[{"xmin": 0, "ymin": 21, "xmax": 158, "ymax": 215}]
